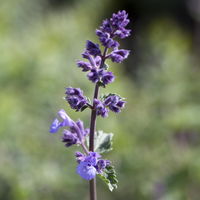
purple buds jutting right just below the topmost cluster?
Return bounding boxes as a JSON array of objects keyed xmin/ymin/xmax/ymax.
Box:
[{"xmin": 108, "ymin": 49, "xmax": 130, "ymax": 63}]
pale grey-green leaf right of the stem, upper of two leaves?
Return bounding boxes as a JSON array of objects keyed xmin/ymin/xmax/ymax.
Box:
[{"xmin": 94, "ymin": 131, "xmax": 113, "ymax": 153}]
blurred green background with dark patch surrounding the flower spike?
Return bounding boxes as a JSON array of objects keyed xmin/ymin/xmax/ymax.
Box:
[{"xmin": 0, "ymin": 0, "xmax": 200, "ymax": 200}]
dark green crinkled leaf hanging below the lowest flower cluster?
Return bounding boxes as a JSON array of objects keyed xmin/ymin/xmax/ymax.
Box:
[{"xmin": 98, "ymin": 165, "xmax": 118, "ymax": 192}]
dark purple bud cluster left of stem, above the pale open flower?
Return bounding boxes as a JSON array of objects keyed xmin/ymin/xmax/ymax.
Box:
[{"xmin": 65, "ymin": 87, "xmax": 88, "ymax": 111}]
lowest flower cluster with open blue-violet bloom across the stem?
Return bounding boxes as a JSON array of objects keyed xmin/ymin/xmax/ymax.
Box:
[{"xmin": 75, "ymin": 152, "xmax": 110, "ymax": 180}]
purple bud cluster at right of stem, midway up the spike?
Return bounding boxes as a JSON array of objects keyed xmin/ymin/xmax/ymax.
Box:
[{"xmin": 104, "ymin": 94, "xmax": 126, "ymax": 113}]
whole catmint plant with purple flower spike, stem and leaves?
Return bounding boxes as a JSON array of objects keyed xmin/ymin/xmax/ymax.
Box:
[{"xmin": 50, "ymin": 11, "xmax": 131, "ymax": 200}]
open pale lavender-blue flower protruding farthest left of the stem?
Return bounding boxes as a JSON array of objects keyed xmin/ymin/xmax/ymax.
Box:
[{"xmin": 49, "ymin": 109, "xmax": 74, "ymax": 133}]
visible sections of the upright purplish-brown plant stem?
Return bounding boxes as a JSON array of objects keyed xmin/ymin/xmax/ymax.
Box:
[{"xmin": 89, "ymin": 47, "xmax": 107, "ymax": 200}]
